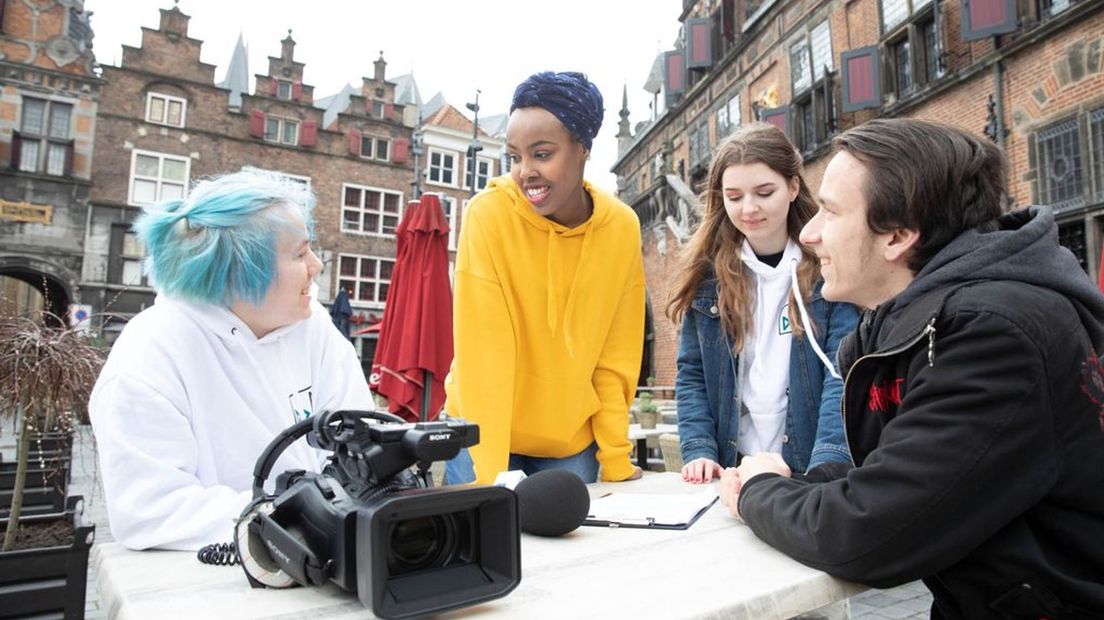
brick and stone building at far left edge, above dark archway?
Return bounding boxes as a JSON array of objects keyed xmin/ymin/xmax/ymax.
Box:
[{"xmin": 0, "ymin": 0, "xmax": 102, "ymax": 318}]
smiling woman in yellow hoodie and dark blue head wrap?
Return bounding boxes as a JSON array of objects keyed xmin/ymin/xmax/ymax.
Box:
[{"xmin": 445, "ymin": 72, "xmax": 645, "ymax": 483}]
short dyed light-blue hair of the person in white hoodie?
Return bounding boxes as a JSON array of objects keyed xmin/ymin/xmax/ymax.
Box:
[{"xmin": 134, "ymin": 171, "xmax": 315, "ymax": 307}]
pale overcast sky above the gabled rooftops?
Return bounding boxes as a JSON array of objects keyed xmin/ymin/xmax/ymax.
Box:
[{"xmin": 84, "ymin": 0, "xmax": 682, "ymax": 191}]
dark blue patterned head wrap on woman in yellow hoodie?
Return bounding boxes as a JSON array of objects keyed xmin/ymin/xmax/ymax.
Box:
[{"xmin": 510, "ymin": 71, "xmax": 605, "ymax": 150}]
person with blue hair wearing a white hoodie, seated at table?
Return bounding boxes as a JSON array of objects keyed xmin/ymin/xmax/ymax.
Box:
[{"xmin": 88, "ymin": 172, "xmax": 372, "ymax": 549}]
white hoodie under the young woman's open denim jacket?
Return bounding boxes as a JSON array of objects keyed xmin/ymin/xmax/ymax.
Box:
[{"xmin": 736, "ymin": 239, "xmax": 802, "ymax": 455}]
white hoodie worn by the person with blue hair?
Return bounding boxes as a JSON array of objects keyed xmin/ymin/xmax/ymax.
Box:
[{"xmin": 88, "ymin": 296, "xmax": 372, "ymax": 549}]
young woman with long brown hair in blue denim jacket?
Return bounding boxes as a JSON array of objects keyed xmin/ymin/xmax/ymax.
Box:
[{"xmin": 667, "ymin": 124, "xmax": 858, "ymax": 483}]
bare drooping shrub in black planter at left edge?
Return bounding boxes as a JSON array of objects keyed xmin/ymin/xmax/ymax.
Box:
[{"xmin": 0, "ymin": 317, "xmax": 104, "ymax": 618}]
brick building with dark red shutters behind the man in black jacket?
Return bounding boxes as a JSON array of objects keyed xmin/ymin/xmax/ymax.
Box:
[{"xmin": 614, "ymin": 0, "xmax": 1104, "ymax": 385}]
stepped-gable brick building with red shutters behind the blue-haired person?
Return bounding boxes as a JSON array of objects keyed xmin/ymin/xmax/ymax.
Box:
[{"xmin": 83, "ymin": 8, "xmax": 416, "ymax": 366}]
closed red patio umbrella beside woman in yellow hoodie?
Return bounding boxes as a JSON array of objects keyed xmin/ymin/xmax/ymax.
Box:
[{"xmin": 369, "ymin": 194, "xmax": 453, "ymax": 421}]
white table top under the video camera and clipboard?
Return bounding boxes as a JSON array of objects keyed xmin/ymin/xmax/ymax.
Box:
[{"xmin": 92, "ymin": 473, "xmax": 864, "ymax": 620}]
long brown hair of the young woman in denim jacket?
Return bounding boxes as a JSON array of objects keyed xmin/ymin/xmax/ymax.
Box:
[{"xmin": 667, "ymin": 122, "xmax": 819, "ymax": 351}]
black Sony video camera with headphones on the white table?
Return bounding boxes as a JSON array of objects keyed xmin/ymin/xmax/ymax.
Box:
[{"xmin": 235, "ymin": 410, "xmax": 521, "ymax": 618}]
